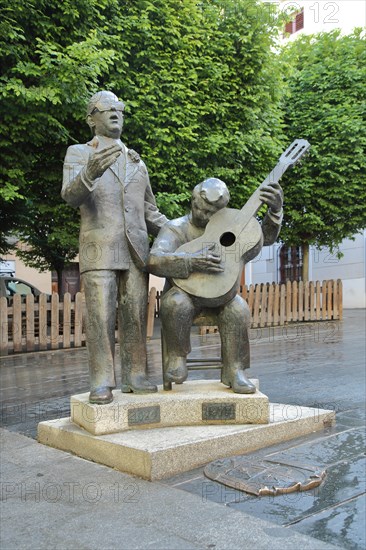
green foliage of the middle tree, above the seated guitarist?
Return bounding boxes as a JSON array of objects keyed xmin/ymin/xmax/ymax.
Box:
[{"xmin": 110, "ymin": 0, "xmax": 282, "ymax": 207}]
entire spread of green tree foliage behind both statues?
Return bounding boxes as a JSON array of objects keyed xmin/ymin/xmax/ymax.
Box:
[{"xmin": 4, "ymin": 0, "xmax": 366, "ymax": 280}]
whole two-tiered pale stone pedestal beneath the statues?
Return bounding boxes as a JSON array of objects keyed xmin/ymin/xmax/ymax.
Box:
[{"xmin": 38, "ymin": 381, "xmax": 335, "ymax": 480}]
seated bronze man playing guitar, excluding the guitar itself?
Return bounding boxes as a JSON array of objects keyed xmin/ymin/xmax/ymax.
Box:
[{"xmin": 148, "ymin": 178, "xmax": 283, "ymax": 393}]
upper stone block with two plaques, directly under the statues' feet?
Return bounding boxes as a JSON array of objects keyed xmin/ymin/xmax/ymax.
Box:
[{"xmin": 71, "ymin": 380, "xmax": 269, "ymax": 435}]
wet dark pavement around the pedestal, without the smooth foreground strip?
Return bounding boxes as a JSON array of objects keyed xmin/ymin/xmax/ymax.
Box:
[{"xmin": 0, "ymin": 310, "xmax": 366, "ymax": 550}]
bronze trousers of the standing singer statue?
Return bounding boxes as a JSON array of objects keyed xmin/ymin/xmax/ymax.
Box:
[{"xmin": 81, "ymin": 262, "xmax": 148, "ymax": 391}]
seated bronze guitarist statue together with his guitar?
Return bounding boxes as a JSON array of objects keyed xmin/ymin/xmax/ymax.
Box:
[{"xmin": 148, "ymin": 139, "xmax": 310, "ymax": 393}]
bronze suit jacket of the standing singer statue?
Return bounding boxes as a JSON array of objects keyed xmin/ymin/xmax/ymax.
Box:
[{"xmin": 61, "ymin": 137, "xmax": 167, "ymax": 273}]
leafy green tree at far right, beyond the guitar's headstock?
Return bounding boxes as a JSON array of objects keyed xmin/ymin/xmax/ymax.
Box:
[{"xmin": 281, "ymin": 30, "xmax": 366, "ymax": 280}]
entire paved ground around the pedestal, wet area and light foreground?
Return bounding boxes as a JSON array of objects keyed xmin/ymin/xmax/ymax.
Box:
[{"xmin": 0, "ymin": 310, "xmax": 365, "ymax": 550}]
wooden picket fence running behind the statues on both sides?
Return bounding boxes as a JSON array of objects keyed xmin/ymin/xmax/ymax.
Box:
[{"xmin": 0, "ymin": 280, "xmax": 342, "ymax": 355}]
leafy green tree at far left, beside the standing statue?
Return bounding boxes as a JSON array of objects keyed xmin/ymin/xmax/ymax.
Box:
[{"xmin": 0, "ymin": 0, "xmax": 118, "ymax": 292}]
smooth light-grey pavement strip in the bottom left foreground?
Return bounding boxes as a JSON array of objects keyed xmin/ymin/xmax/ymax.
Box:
[{"xmin": 0, "ymin": 430, "xmax": 339, "ymax": 550}]
